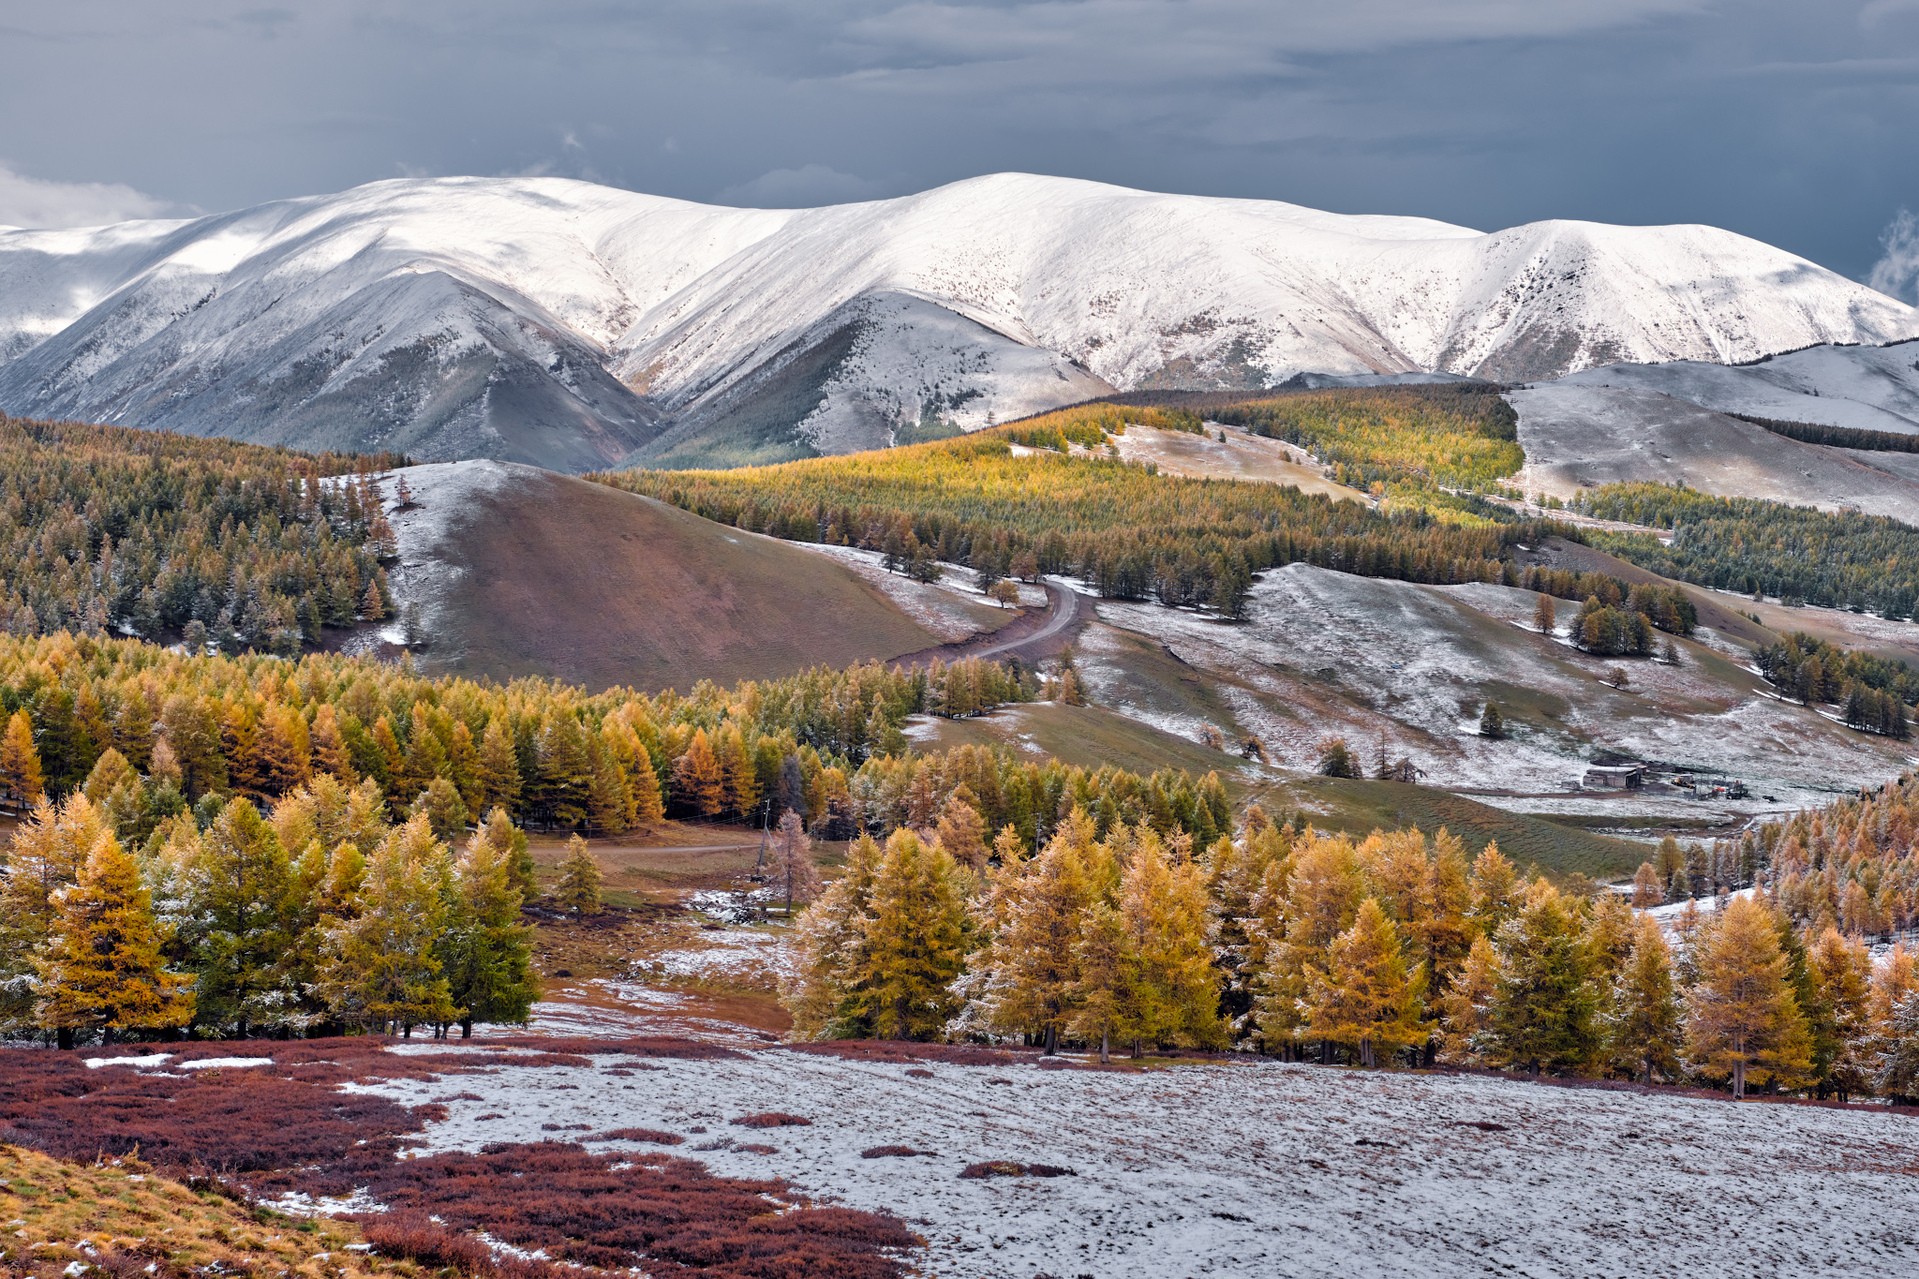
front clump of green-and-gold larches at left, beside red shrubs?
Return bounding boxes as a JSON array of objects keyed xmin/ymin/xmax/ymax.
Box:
[{"xmin": 0, "ymin": 775, "xmax": 535, "ymax": 1047}]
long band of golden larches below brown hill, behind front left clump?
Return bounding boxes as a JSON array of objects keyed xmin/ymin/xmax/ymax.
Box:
[{"xmin": 0, "ymin": 634, "xmax": 1230, "ymax": 845}]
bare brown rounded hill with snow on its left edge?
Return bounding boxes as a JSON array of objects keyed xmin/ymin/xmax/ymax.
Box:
[{"xmin": 370, "ymin": 461, "xmax": 936, "ymax": 689}]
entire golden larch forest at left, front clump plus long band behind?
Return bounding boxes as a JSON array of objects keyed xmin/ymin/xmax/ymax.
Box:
[{"xmin": 0, "ymin": 634, "xmax": 1232, "ymax": 1041}]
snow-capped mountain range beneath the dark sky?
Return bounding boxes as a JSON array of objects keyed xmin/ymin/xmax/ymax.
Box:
[{"xmin": 0, "ymin": 175, "xmax": 1919, "ymax": 469}]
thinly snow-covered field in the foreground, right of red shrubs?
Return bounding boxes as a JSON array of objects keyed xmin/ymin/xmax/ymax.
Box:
[{"xmin": 353, "ymin": 1049, "xmax": 1919, "ymax": 1279}]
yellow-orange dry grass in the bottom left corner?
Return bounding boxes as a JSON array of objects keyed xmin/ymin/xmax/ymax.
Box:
[{"xmin": 0, "ymin": 1146, "xmax": 404, "ymax": 1279}]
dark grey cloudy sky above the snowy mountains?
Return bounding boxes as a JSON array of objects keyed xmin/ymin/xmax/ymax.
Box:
[{"xmin": 0, "ymin": 0, "xmax": 1919, "ymax": 286}]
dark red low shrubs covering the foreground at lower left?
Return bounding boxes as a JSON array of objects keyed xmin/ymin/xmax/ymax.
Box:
[{"xmin": 0, "ymin": 1039, "xmax": 917, "ymax": 1279}]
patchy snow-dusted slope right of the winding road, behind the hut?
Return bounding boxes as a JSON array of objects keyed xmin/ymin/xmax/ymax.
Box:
[{"xmin": 1080, "ymin": 565, "xmax": 1909, "ymax": 816}]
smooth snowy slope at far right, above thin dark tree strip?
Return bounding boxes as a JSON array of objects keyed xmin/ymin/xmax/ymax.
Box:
[{"xmin": 1562, "ymin": 342, "xmax": 1919, "ymax": 434}]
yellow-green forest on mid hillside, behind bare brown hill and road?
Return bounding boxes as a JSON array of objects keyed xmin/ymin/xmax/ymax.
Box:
[{"xmin": 591, "ymin": 405, "xmax": 1665, "ymax": 618}]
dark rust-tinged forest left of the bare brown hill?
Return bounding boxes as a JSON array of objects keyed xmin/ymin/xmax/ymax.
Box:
[{"xmin": 0, "ymin": 415, "xmax": 405, "ymax": 655}]
